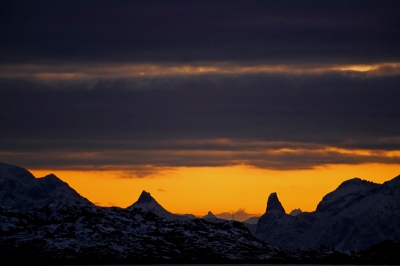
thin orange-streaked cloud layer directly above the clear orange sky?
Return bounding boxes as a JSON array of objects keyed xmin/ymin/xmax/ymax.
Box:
[{"xmin": 0, "ymin": 144, "xmax": 400, "ymax": 174}]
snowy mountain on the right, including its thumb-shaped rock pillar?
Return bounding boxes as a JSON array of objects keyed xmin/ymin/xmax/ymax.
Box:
[{"xmin": 256, "ymin": 176, "xmax": 400, "ymax": 250}]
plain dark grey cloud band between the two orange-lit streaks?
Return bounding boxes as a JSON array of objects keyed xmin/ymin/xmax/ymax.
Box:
[{"xmin": 0, "ymin": 73, "xmax": 400, "ymax": 145}]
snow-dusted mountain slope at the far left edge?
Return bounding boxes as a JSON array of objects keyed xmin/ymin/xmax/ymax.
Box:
[{"xmin": 0, "ymin": 162, "xmax": 92, "ymax": 210}]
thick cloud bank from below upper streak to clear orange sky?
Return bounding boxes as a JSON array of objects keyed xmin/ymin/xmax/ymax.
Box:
[{"xmin": 0, "ymin": 72, "xmax": 400, "ymax": 170}]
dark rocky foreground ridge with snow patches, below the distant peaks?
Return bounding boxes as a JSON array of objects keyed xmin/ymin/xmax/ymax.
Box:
[{"xmin": 0, "ymin": 205, "xmax": 400, "ymax": 265}]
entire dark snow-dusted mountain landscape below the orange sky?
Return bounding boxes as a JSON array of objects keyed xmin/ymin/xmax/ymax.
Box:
[{"xmin": 0, "ymin": 163, "xmax": 400, "ymax": 262}]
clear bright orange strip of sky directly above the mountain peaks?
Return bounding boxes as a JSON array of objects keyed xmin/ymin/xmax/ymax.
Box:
[{"xmin": 31, "ymin": 164, "xmax": 400, "ymax": 219}]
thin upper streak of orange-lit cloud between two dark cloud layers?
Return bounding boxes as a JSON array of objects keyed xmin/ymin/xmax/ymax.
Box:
[{"xmin": 0, "ymin": 62, "xmax": 400, "ymax": 81}]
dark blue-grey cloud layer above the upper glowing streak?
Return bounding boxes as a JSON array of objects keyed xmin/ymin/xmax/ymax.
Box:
[{"xmin": 0, "ymin": 0, "xmax": 400, "ymax": 64}]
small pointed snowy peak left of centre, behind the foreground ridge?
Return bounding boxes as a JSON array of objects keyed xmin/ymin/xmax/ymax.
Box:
[{"xmin": 127, "ymin": 190, "xmax": 191, "ymax": 220}]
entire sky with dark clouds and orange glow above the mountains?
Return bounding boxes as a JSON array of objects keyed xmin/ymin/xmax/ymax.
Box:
[{"xmin": 0, "ymin": 0, "xmax": 400, "ymax": 220}]
